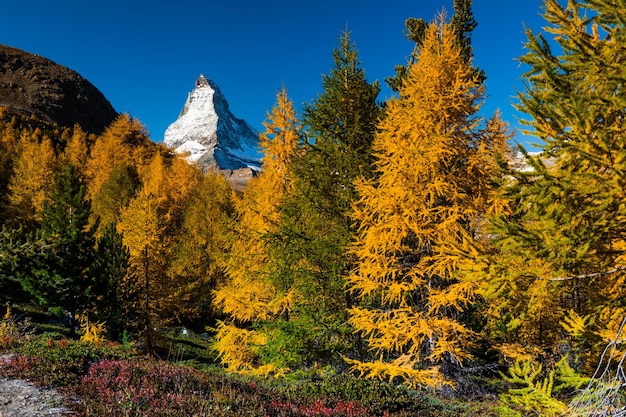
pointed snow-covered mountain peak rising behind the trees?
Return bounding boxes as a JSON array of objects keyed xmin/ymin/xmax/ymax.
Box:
[{"xmin": 163, "ymin": 75, "xmax": 261, "ymax": 182}]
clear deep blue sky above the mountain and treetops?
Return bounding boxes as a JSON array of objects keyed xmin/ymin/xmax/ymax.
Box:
[{"xmin": 0, "ymin": 0, "xmax": 545, "ymax": 148}]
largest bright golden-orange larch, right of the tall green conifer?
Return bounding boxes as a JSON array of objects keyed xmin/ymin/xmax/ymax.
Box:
[{"xmin": 348, "ymin": 15, "xmax": 507, "ymax": 386}]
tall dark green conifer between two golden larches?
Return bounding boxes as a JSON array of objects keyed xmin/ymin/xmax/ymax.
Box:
[{"xmin": 267, "ymin": 32, "xmax": 380, "ymax": 365}]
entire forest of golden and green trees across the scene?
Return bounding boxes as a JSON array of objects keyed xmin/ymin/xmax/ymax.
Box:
[{"xmin": 0, "ymin": 0, "xmax": 626, "ymax": 415}]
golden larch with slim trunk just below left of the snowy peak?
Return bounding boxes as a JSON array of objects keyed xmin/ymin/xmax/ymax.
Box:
[{"xmin": 117, "ymin": 148, "xmax": 201, "ymax": 340}]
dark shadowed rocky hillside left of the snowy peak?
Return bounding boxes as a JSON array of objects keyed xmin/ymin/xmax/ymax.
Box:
[{"xmin": 0, "ymin": 45, "xmax": 118, "ymax": 133}]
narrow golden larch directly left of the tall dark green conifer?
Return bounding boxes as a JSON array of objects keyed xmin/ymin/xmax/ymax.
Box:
[{"xmin": 215, "ymin": 87, "xmax": 300, "ymax": 373}]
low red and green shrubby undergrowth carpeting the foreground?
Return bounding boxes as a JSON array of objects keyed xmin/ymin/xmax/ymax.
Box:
[{"xmin": 0, "ymin": 308, "xmax": 496, "ymax": 417}]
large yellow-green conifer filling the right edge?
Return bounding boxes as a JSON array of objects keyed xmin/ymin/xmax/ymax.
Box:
[{"xmin": 472, "ymin": 0, "xmax": 626, "ymax": 367}]
